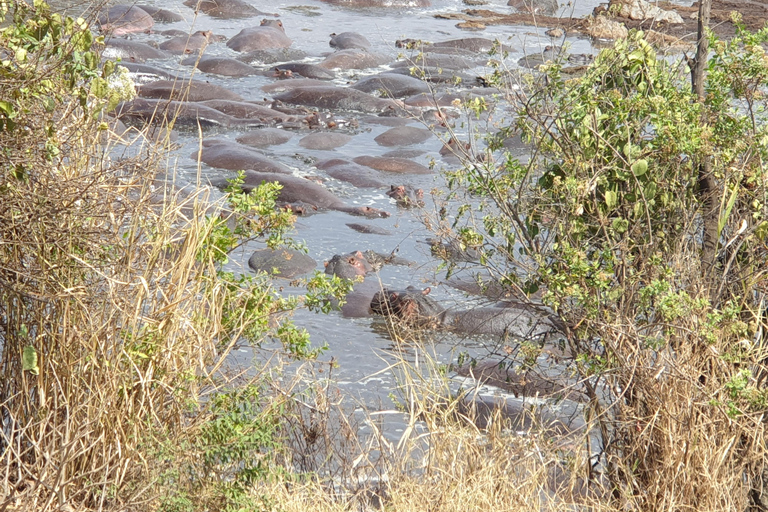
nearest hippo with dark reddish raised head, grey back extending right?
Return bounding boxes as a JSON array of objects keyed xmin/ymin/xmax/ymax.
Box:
[{"xmin": 371, "ymin": 286, "xmax": 556, "ymax": 339}]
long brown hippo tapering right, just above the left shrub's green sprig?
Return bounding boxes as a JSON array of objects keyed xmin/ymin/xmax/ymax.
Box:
[{"xmin": 230, "ymin": 171, "xmax": 389, "ymax": 217}]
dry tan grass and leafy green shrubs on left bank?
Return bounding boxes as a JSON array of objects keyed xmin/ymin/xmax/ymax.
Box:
[{"xmin": 0, "ymin": 0, "xmax": 342, "ymax": 511}]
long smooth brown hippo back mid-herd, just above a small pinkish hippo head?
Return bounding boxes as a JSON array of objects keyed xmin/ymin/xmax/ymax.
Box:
[{"xmin": 273, "ymin": 85, "xmax": 402, "ymax": 113}]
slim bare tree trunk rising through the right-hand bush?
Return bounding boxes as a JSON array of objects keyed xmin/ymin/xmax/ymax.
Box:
[{"xmin": 691, "ymin": 0, "xmax": 720, "ymax": 276}]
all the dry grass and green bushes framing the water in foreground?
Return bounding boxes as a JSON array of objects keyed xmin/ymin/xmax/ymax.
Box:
[{"xmin": 0, "ymin": 0, "xmax": 768, "ymax": 512}]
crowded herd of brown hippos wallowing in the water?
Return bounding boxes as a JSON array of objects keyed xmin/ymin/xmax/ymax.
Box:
[{"xmin": 98, "ymin": 0, "xmax": 568, "ymax": 348}]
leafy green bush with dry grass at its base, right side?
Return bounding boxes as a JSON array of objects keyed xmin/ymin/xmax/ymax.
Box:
[{"xmin": 443, "ymin": 29, "xmax": 768, "ymax": 510}]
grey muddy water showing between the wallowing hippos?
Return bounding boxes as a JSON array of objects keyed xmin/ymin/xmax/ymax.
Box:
[{"xmin": 58, "ymin": 0, "xmax": 616, "ymax": 437}]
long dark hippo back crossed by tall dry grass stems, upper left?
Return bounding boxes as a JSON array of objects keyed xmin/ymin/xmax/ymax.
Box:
[{"xmin": 116, "ymin": 98, "xmax": 251, "ymax": 129}]
